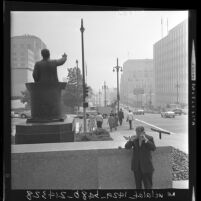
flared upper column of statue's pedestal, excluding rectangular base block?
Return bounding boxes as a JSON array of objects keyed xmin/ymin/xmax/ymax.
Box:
[{"xmin": 26, "ymin": 82, "xmax": 66, "ymax": 123}]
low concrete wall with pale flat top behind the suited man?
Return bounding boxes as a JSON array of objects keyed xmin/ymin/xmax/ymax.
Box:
[{"xmin": 11, "ymin": 142, "xmax": 172, "ymax": 189}]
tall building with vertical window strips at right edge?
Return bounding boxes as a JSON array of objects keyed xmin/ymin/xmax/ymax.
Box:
[{"xmin": 153, "ymin": 20, "xmax": 188, "ymax": 107}]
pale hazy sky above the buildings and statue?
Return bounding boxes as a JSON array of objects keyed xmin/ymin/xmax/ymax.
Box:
[{"xmin": 11, "ymin": 10, "xmax": 188, "ymax": 91}]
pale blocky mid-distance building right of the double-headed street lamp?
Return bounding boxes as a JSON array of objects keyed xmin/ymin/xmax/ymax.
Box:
[{"xmin": 120, "ymin": 59, "xmax": 155, "ymax": 107}]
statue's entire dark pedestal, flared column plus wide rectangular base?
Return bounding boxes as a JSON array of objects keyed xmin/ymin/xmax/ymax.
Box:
[{"xmin": 15, "ymin": 82, "xmax": 74, "ymax": 144}]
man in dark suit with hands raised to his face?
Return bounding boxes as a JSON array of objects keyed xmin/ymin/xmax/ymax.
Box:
[{"xmin": 125, "ymin": 126, "xmax": 156, "ymax": 189}]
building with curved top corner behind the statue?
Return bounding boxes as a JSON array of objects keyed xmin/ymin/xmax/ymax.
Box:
[{"xmin": 11, "ymin": 35, "xmax": 47, "ymax": 97}]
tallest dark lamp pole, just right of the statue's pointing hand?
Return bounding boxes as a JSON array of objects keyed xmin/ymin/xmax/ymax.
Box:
[{"xmin": 80, "ymin": 19, "xmax": 86, "ymax": 133}]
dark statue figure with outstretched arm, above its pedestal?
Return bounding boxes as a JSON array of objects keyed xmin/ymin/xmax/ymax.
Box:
[{"xmin": 33, "ymin": 49, "xmax": 67, "ymax": 83}]
